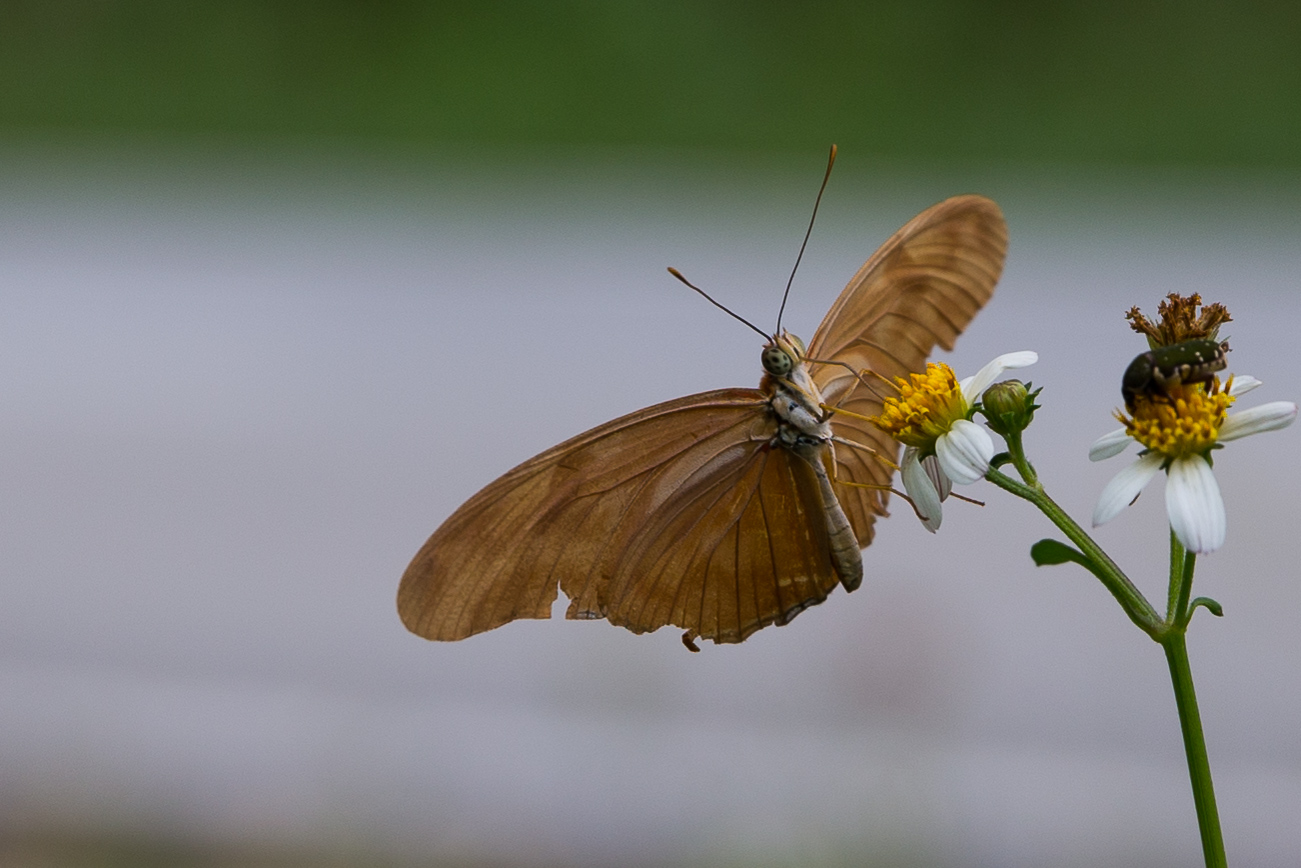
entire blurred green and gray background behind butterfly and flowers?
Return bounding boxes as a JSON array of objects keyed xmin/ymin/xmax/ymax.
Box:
[{"xmin": 0, "ymin": 1, "xmax": 1301, "ymax": 868}]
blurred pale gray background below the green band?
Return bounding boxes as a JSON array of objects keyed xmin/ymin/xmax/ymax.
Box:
[{"xmin": 0, "ymin": 145, "xmax": 1301, "ymax": 865}]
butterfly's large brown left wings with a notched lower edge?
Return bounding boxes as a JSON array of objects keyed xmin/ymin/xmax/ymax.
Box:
[{"xmin": 398, "ymin": 389, "xmax": 837, "ymax": 642}]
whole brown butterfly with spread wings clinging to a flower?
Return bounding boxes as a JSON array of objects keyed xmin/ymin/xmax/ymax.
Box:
[{"xmin": 398, "ymin": 184, "xmax": 1007, "ymax": 647}]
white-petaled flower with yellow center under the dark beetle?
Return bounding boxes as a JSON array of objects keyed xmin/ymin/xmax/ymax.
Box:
[{"xmin": 1089, "ymin": 376, "xmax": 1297, "ymax": 554}]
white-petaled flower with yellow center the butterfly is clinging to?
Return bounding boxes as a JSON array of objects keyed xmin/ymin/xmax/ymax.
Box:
[{"xmin": 873, "ymin": 350, "xmax": 1039, "ymax": 532}]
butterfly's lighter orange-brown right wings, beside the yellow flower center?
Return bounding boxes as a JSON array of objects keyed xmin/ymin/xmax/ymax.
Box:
[{"xmin": 808, "ymin": 195, "xmax": 1007, "ymax": 545}]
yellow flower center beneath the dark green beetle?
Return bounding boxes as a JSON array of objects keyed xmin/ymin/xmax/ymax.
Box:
[{"xmin": 1116, "ymin": 377, "xmax": 1233, "ymax": 458}]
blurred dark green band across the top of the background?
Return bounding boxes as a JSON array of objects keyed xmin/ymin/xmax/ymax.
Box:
[{"xmin": 0, "ymin": 0, "xmax": 1301, "ymax": 169}]
